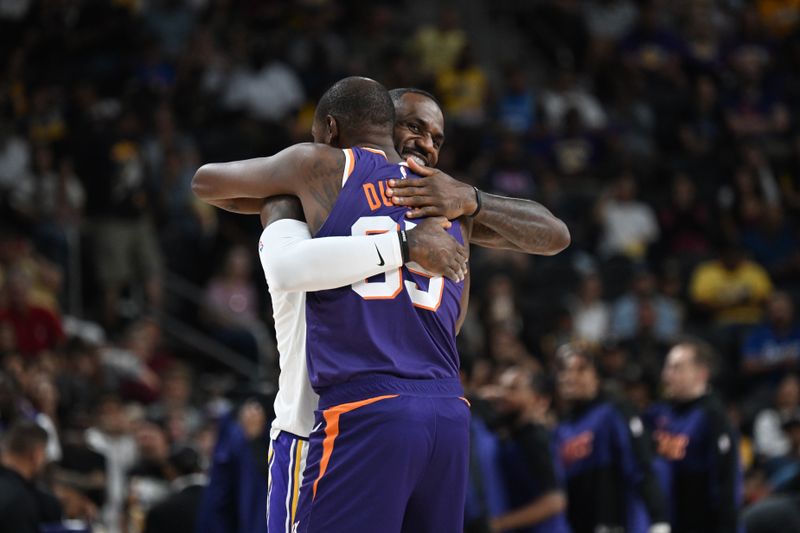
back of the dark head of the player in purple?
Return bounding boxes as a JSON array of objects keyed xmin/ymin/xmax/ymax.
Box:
[{"xmin": 314, "ymin": 76, "xmax": 394, "ymax": 138}]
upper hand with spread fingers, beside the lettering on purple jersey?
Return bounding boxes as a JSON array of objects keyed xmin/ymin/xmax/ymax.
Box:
[{"xmin": 386, "ymin": 158, "xmax": 478, "ymax": 220}]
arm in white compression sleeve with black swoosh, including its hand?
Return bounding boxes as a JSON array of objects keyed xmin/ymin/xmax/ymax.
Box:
[{"xmin": 259, "ymin": 196, "xmax": 467, "ymax": 292}]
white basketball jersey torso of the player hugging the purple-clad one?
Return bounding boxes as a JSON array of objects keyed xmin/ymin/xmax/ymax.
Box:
[{"xmin": 259, "ymin": 227, "xmax": 319, "ymax": 439}]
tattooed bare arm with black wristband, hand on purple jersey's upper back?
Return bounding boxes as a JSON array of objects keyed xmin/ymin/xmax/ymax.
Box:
[{"xmin": 387, "ymin": 159, "xmax": 570, "ymax": 255}]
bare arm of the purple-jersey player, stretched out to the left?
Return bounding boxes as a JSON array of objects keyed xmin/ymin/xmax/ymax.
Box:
[{"xmin": 192, "ymin": 143, "xmax": 344, "ymax": 214}]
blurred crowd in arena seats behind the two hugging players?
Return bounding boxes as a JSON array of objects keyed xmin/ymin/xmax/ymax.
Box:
[{"xmin": 0, "ymin": 0, "xmax": 800, "ymax": 533}]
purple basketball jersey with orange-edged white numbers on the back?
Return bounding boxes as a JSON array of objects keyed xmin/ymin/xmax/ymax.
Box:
[{"xmin": 306, "ymin": 148, "xmax": 463, "ymax": 391}]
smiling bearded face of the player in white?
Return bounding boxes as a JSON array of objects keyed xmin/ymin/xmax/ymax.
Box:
[{"xmin": 394, "ymin": 93, "xmax": 444, "ymax": 167}]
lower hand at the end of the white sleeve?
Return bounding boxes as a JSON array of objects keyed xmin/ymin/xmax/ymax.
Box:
[{"xmin": 406, "ymin": 217, "xmax": 468, "ymax": 282}]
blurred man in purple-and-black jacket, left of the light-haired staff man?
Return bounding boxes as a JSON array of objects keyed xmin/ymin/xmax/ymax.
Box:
[{"xmin": 556, "ymin": 344, "xmax": 670, "ymax": 533}]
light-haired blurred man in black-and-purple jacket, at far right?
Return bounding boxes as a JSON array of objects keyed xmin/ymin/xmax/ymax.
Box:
[{"xmin": 647, "ymin": 341, "xmax": 742, "ymax": 533}]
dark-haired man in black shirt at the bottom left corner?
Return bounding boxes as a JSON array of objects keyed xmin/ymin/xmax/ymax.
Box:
[{"xmin": 0, "ymin": 421, "xmax": 61, "ymax": 533}]
